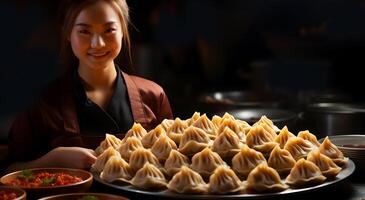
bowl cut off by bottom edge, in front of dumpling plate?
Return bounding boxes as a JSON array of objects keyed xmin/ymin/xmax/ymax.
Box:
[{"xmin": 39, "ymin": 193, "xmax": 128, "ymax": 200}]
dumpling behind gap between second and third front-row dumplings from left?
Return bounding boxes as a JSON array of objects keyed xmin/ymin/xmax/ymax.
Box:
[{"xmin": 165, "ymin": 149, "xmax": 190, "ymax": 176}]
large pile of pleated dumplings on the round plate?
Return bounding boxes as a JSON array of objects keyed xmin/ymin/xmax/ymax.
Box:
[{"xmin": 91, "ymin": 112, "xmax": 348, "ymax": 194}]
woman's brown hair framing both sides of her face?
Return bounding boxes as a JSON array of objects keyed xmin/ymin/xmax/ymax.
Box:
[{"xmin": 58, "ymin": 0, "xmax": 132, "ymax": 73}]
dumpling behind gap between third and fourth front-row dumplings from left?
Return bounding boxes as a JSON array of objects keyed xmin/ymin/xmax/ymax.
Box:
[{"xmin": 191, "ymin": 148, "xmax": 225, "ymax": 177}]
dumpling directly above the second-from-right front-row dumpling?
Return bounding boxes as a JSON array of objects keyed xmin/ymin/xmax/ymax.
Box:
[{"xmin": 284, "ymin": 137, "xmax": 316, "ymax": 160}]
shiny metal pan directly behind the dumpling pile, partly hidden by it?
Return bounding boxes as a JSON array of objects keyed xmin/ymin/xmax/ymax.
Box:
[{"xmin": 217, "ymin": 108, "xmax": 298, "ymax": 132}]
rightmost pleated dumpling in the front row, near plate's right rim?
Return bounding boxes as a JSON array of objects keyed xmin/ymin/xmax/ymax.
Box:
[{"xmin": 307, "ymin": 150, "xmax": 341, "ymax": 178}]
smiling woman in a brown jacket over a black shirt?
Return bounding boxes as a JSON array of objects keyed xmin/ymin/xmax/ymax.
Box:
[{"xmin": 8, "ymin": 0, "xmax": 172, "ymax": 171}]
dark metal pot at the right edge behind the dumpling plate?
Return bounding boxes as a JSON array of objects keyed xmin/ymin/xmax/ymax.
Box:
[{"xmin": 300, "ymin": 103, "xmax": 365, "ymax": 137}]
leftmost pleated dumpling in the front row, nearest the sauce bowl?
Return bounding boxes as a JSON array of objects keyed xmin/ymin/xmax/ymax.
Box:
[{"xmin": 100, "ymin": 156, "xmax": 134, "ymax": 182}]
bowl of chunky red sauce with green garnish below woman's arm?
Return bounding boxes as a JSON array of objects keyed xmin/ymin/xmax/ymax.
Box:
[{"xmin": 0, "ymin": 168, "xmax": 93, "ymax": 199}]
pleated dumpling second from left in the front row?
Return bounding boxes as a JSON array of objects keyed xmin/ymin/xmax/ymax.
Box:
[{"xmin": 130, "ymin": 162, "xmax": 167, "ymax": 189}]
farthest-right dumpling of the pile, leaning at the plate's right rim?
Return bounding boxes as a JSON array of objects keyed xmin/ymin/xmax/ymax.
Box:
[{"xmin": 319, "ymin": 136, "xmax": 349, "ymax": 166}]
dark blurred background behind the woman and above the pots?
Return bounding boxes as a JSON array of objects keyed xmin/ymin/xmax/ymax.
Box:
[{"xmin": 0, "ymin": 0, "xmax": 365, "ymax": 141}]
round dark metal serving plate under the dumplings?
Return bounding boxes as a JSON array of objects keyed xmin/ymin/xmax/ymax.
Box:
[{"xmin": 93, "ymin": 159, "xmax": 355, "ymax": 199}]
